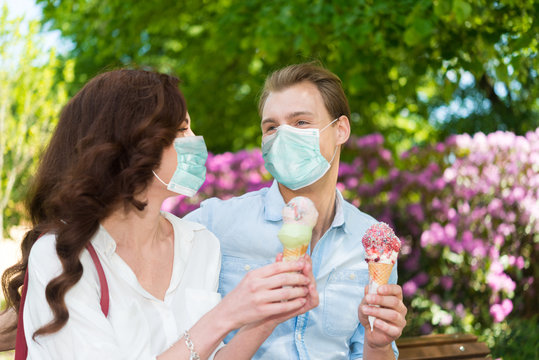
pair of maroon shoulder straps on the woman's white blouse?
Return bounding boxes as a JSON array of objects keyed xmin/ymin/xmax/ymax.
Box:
[{"xmin": 14, "ymin": 243, "xmax": 109, "ymax": 360}]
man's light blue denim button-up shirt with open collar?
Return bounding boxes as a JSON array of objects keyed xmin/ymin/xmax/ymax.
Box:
[{"xmin": 186, "ymin": 181, "xmax": 398, "ymax": 360}]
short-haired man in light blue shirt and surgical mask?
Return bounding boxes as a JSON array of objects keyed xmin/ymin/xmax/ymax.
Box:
[{"xmin": 186, "ymin": 64, "xmax": 406, "ymax": 360}]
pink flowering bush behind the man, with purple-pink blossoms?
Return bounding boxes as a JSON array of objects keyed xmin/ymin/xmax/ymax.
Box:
[{"xmin": 165, "ymin": 129, "xmax": 539, "ymax": 345}]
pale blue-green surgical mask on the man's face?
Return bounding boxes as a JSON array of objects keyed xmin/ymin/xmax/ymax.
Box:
[{"xmin": 262, "ymin": 118, "xmax": 338, "ymax": 190}]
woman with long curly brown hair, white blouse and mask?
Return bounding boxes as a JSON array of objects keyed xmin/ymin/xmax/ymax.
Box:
[{"xmin": 2, "ymin": 70, "xmax": 318, "ymax": 359}]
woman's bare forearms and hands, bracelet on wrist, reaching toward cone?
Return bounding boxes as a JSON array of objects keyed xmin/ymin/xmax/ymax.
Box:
[{"xmin": 158, "ymin": 260, "xmax": 316, "ymax": 360}]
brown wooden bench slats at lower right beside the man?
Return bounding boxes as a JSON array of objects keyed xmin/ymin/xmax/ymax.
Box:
[{"xmin": 397, "ymin": 334, "xmax": 490, "ymax": 360}]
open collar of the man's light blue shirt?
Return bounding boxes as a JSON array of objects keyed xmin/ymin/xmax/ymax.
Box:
[{"xmin": 264, "ymin": 180, "xmax": 347, "ymax": 232}]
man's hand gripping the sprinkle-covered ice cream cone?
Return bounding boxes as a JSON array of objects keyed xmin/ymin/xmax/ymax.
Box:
[{"xmin": 358, "ymin": 285, "xmax": 408, "ymax": 348}]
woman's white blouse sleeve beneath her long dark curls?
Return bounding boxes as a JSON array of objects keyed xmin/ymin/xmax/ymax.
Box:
[{"xmin": 23, "ymin": 235, "xmax": 136, "ymax": 360}]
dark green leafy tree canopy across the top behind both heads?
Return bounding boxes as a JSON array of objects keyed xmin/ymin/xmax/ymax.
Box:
[{"xmin": 38, "ymin": 0, "xmax": 539, "ymax": 151}]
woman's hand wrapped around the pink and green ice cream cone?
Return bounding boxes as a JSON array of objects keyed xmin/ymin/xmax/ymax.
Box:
[{"xmin": 218, "ymin": 259, "xmax": 318, "ymax": 330}]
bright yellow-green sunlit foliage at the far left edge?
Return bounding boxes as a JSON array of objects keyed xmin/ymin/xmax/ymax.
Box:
[{"xmin": 0, "ymin": 7, "xmax": 73, "ymax": 236}]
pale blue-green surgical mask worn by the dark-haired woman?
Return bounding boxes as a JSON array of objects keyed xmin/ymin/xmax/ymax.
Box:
[{"xmin": 153, "ymin": 136, "xmax": 208, "ymax": 197}]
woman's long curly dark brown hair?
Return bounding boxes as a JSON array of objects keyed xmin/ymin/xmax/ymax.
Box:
[{"xmin": 2, "ymin": 70, "xmax": 187, "ymax": 337}]
